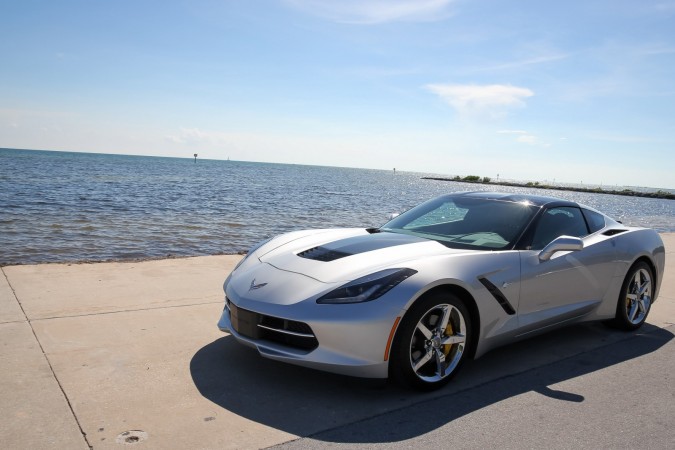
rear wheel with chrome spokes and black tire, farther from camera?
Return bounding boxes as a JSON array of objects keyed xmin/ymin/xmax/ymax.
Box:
[{"xmin": 611, "ymin": 261, "xmax": 654, "ymax": 331}]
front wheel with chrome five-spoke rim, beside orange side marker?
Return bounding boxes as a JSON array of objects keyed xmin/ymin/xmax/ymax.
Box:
[{"xmin": 390, "ymin": 292, "xmax": 472, "ymax": 391}]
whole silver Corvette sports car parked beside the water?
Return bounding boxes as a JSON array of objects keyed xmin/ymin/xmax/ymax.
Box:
[{"xmin": 218, "ymin": 192, "xmax": 665, "ymax": 389}]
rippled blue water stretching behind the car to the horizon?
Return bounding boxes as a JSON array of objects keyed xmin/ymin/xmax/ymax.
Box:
[{"xmin": 0, "ymin": 149, "xmax": 675, "ymax": 265}]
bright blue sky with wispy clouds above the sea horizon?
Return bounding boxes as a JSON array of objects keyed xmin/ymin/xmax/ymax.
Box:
[{"xmin": 0, "ymin": 0, "xmax": 675, "ymax": 189}]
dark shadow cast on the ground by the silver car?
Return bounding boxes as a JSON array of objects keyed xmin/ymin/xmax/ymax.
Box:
[{"xmin": 190, "ymin": 324, "xmax": 673, "ymax": 443}]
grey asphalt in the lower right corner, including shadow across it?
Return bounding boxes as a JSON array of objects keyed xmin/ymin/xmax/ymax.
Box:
[{"xmin": 273, "ymin": 326, "xmax": 675, "ymax": 450}]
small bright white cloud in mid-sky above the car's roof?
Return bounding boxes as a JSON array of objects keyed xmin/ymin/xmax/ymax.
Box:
[{"xmin": 426, "ymin": 84, "xmax": 534, "ymax": 115}]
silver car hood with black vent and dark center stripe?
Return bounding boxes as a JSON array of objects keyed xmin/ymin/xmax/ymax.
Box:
[{"xmin": 258, "ymin": 228, "xmax": 471, "ymax": 283}]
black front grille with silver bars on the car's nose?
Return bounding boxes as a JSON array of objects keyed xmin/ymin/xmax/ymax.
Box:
[{"xmin": 227, "ymin": 299, "xmax": 319, "ymax": 350}]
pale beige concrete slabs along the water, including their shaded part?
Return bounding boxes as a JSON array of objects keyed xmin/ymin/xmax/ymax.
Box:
[{"xmin": 0, "ymin": 233, "xmax": 675, "ymax": 449}]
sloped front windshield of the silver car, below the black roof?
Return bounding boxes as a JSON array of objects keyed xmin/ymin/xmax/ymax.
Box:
[{"xmin": 380, "ymin": 195, "xmax": 538, "ymax": 250}]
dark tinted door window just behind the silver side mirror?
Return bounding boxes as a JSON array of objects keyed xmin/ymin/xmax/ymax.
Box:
[{"xmin": 530, "ymin": 206, "xmax": 588, "ymax": 250}]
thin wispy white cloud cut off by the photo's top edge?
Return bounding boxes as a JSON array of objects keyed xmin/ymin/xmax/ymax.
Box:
[{"xmin": 285, "ymin": 0, "xmax": 455, "ymax": 24}]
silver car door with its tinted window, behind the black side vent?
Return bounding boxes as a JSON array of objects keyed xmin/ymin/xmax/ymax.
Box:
[{"xmin": 518, "ymin": 206, "xmax": 614, "ymax": 334}]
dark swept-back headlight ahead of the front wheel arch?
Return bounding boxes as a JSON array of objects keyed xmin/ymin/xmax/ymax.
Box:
[{"xmin": 316, "ymin": 269, "xmax": 417, "ymax": 304}]
